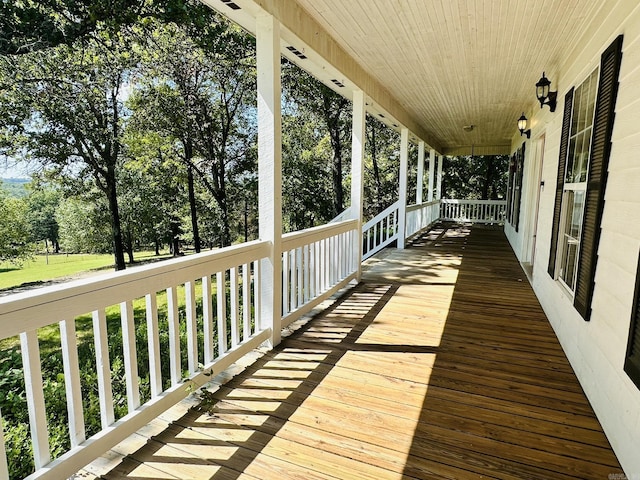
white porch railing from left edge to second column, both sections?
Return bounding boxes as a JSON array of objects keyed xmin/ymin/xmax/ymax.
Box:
[{"xmin": 0, "ymin": 220, "xmax": 360, "ymax": 479}]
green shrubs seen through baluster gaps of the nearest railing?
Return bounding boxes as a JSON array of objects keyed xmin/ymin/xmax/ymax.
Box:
[{"xmin": 0, "ymin": 276, "xmax": 253, "ymax": 479}]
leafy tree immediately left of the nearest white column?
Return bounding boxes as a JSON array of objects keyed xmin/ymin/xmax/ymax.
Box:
[{"xmin": 131, "ymin": 17, "xmax": 256, "ymax": 246}]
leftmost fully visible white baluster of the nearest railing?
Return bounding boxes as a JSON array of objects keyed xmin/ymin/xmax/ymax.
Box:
[{"xmin": 20, "ymin": 330, "xmax": 51, "ymax": 470}]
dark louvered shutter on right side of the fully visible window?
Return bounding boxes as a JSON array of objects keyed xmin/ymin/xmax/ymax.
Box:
[{"xmin": 573, "ymin": 35, "xmax": 622, "ymax": 320}]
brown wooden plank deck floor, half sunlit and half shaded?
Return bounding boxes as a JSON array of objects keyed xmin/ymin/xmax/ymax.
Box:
[{"xmin": 87, "ymin": 227, "xmax": 621, "ymax": 480}]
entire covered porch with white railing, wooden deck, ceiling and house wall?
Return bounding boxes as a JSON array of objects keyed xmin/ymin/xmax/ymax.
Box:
[{"xmin": 0, "ymin": 0, "xmax": 640, "ymax": 480}]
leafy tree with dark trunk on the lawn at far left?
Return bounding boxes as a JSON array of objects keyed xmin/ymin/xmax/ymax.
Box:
[{"xmin": 0, "ymin": 30, "xmax": 137, "ymax": 270}]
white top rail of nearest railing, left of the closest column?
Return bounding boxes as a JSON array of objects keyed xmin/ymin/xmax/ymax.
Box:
[{"xmin": 0, "ymin": 240, "xmax": 269, "ymax": 339}]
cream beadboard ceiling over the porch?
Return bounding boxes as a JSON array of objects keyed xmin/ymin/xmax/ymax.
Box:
[{"xmin": 205, "ymin": 0, "xmax": 608, "ymax": 154}]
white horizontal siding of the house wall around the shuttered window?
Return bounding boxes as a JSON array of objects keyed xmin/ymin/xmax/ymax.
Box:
[{"xmin": 505, "ymin": 0, "xmax": 640, "ymax": 472}]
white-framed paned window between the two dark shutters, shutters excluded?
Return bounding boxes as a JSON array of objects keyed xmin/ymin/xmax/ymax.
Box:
[{"xmin": 558, "ymin": 70, "xmax": 598, "ymax": 292}]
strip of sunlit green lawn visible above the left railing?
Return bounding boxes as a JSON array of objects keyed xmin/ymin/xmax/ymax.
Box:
[{"xmin": 0, "ymin": 251, "xmax": 168, "ymax": 290}]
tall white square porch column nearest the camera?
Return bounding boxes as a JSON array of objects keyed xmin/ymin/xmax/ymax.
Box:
[{"xmin": 256, "ymin": 14, "xmax": 282, "ymax": 347}]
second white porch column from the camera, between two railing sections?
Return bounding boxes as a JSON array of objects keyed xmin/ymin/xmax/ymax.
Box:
[{"xmin": 351, "ymin": 90, "xmax": 366, "ymax": 281}]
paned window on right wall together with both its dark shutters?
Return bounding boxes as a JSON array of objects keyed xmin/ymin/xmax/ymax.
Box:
[{"xmin": 548, "ymin": 35, "xmax": 622, "ymax": 320}]
